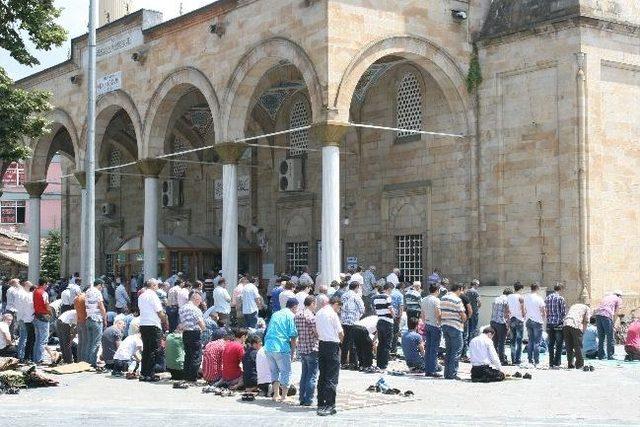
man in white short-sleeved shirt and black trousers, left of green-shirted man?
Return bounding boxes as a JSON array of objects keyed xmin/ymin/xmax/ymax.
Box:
[{"xmin": 138, "ymin": 279, "xmax": 166, "ymax": 382}]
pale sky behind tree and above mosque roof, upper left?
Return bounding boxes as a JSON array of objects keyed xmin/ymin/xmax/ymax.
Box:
[{"xmin": 0, "ymin": 0, "xmax": 214, "ymax": 80}]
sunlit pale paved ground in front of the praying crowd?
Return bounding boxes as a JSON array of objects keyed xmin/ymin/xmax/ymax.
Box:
[{"xmin": 0, "ymin": 352, "xmax": 640, "ymax": 427}]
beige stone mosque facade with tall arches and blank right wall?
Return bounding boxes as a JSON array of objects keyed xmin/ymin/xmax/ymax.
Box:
[{"xmin": 13, "ymin": 0, "xmax": 640, "ymax": 308}]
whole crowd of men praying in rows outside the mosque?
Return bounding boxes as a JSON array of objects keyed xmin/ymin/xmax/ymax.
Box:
[{"xmin": 0, "ymin": 266, "xmax": 640, "ymax": 416}]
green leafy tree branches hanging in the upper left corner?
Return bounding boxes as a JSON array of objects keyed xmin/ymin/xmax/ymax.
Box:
[{"xmin": 0, "ymin": 0, "xmax": 67, "ymax": 163}]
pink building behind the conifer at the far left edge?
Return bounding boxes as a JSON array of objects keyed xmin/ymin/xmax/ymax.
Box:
[{"xmin": 0, "ymin": 156, "xmax": 62, "ymax": 236}]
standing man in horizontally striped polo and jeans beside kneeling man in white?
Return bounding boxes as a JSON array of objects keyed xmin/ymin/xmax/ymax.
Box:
[{"xmin": 440, "ymin": 284, "xmax": 467, "ymax": 380}]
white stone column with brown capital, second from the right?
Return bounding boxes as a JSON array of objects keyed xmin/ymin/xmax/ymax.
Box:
[{"xmin": 215, "ymin": 142, "xmax": 247, "ymax": 292}]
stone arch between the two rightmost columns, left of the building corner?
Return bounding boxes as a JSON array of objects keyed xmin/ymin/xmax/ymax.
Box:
[{"xmin": 222, "ymin": 37, "xmax": 326, "ymax": 140}]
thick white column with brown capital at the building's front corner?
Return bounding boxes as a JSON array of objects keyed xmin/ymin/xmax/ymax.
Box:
[{"xmin": 311, "ymin": 122, "xmax": 349, "ymax": 285}]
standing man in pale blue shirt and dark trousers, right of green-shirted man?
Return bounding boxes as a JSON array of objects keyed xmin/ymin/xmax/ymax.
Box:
[{"xmin": 180, "ymin": 291, "xmax": 204, "ymax": 381}]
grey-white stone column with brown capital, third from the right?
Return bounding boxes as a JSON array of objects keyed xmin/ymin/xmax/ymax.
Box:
[{"xmin": 138, "ymin": 159, "xmax": 165, "ymax": 280}]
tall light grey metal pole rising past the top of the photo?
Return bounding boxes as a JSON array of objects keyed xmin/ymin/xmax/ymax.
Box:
[{"xmin": 82, "ymin": 0, "xmax": 99, "ymax": 286}]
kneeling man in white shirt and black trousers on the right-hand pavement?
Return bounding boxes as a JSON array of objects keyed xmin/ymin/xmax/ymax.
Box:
[{"xmin": 469, "ymin": 326, "xmax": 505, "ymax": 383}]
